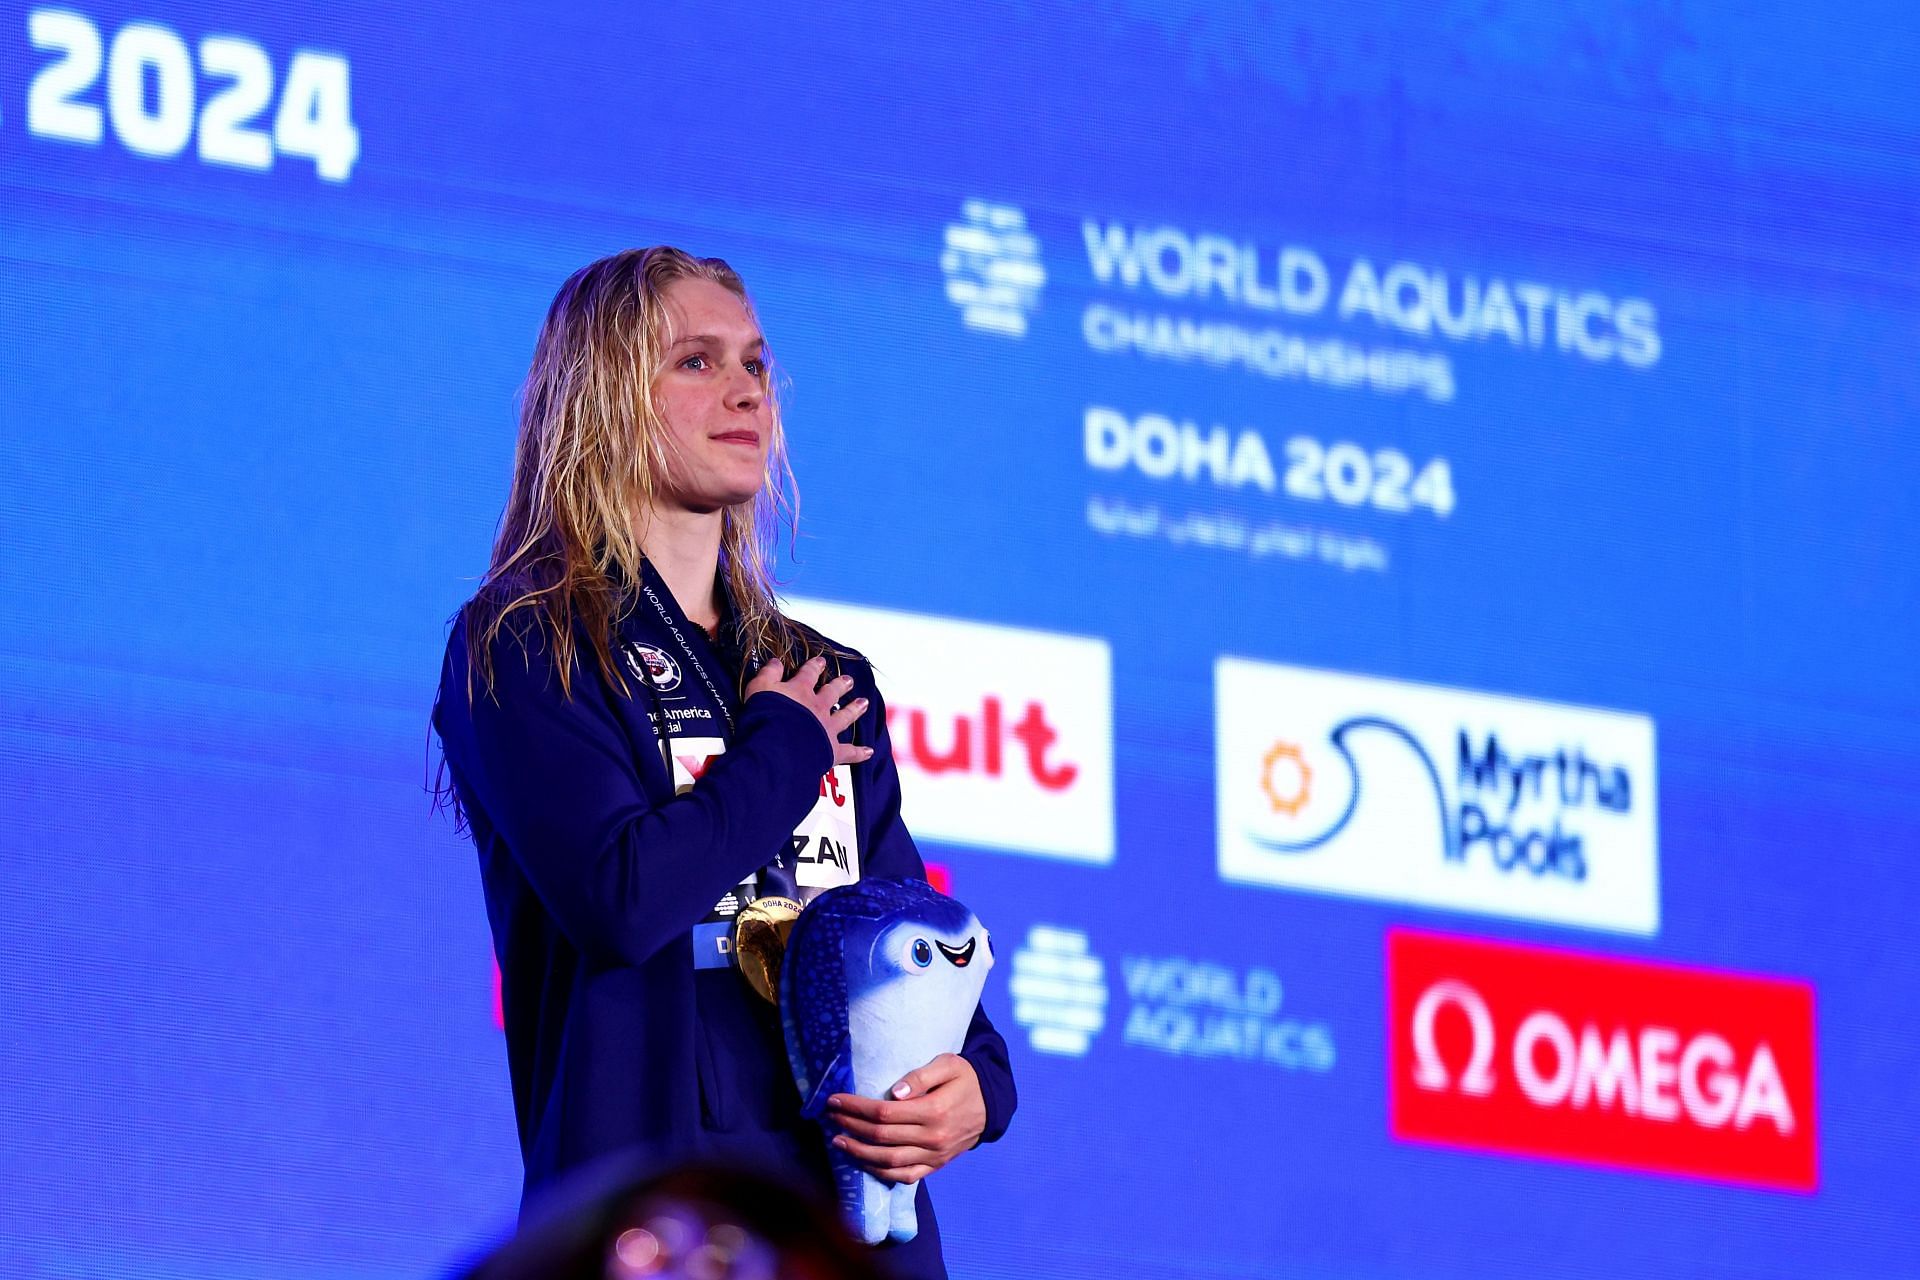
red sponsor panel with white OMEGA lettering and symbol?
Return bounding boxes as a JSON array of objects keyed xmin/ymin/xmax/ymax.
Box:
[{"xmin": 1386, "ymin": 929, "xmax": 1818, "ymax": 1192}]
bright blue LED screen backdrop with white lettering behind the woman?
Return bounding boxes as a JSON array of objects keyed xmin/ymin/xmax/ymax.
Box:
[{"xmin": 0, "ymin": 4, "xmax": 1920, "ymax": 1278}]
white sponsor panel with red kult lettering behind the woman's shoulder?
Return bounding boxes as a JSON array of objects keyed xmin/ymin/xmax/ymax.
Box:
[{"xmin": 787, "ymin": 601, "xmax": 1114, "ymax": 864}]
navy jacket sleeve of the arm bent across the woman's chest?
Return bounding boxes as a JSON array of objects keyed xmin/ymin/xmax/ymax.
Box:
[{"xmin": 434, "ymin": 618, "xmax": 833, "ymax": 965}]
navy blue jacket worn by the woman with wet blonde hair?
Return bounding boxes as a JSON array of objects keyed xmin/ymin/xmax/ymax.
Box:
[{"xmin": 434, "ymin": 594, "xmax": 1016, "ymax": 1276}]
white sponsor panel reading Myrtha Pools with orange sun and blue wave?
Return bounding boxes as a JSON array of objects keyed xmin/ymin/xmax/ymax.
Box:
[{"xmin": 1213, "ymin": 658, "xmax": 1659, "ymax": 935}]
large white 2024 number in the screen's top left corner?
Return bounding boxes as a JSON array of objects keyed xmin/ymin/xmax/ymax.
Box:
[{"xmin": 27, "ymin": 10, "xmax": 359, "ymax": 182}]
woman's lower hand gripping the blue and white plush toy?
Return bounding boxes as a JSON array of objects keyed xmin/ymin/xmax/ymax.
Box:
[{"xmin": 828, "ymin": 1054, "xmax": 987, "ymax": 1182}]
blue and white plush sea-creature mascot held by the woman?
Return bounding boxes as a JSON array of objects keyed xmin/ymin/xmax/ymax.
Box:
[{"xmin": 780, "ymin": 879, "xmax": 993, "ymax": 1244}]
